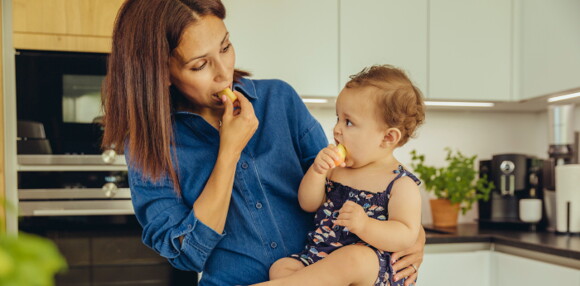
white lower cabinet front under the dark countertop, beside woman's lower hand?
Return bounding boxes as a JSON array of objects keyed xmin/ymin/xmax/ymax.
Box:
[{"xmin": 417, "ymin": 250, "xmax": 492, "ymax": 286}]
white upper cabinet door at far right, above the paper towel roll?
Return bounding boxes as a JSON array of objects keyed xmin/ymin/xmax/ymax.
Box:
[{"xmin": 518, "ymin": 0, "xmax": 580, "ymax": 99}]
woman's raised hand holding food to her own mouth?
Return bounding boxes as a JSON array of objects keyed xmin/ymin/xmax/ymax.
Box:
[{"xmin": 220, "ymin": 91, "xmax": 259, "ymax": 156}]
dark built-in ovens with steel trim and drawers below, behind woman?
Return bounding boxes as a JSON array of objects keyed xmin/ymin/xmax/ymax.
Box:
[{"xmin": 15, "ymin": 50, "xmax": 197, "ymax": 286}]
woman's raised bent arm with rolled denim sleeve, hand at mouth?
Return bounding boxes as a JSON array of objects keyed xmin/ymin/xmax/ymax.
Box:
[{"xmin": 128, "ymin": 94, "xmax": 258, "ymax": 272}]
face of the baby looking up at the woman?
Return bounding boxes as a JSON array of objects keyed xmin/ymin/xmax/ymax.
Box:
[{"xmin": 333, "ymin": 87, "xmax": 387, "ymax": 168}]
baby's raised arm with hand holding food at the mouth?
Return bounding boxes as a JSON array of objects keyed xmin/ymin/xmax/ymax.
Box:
[{"xmin": 298, "ymin": 144, "xmax": 344, "ymax": 212}]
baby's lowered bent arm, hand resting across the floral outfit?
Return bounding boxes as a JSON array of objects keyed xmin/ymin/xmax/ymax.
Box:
[{"xmin": 335, "ymin": 178, "xmax": 421, "ymax": 252}]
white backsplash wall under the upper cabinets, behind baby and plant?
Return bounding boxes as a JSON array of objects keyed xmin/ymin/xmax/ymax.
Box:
[{"xmin": 310, "ymin": 106, "xmax": 580, "ymax": 223}]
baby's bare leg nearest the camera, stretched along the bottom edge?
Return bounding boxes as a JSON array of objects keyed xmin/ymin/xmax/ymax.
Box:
[{"xmin": 251, "ymin": 245, "xmax": 379, "ymax": 286}]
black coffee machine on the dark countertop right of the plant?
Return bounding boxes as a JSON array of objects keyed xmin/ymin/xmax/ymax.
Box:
[{"xmin": 478, "ymin": 154, "xmax": 544, "ymax": 230}]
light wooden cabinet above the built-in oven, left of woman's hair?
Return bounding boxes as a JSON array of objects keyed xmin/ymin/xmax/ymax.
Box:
[{"xmin": 13, "ymin": 0, "xmax": 123, "ymax": 52}]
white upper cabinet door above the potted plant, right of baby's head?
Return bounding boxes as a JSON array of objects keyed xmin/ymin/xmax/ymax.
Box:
[{"xmin": 426, "ymin": 0, "xmax": 513, "ymax": 101}]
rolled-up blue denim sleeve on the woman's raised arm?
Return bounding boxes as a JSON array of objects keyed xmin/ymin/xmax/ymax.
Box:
[{"xmin": 129, "ymin": 168, "xmax": 225, "ymax": 272}]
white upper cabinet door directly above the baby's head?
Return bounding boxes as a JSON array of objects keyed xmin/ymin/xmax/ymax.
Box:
[{"xmin": 340, "ymin": 0, "xmax": 428, "ymax": 94}]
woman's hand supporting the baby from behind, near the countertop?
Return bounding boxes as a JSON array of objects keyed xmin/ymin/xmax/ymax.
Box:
[{"xmin": 391, "ymin": 228, "xmax": 425, "ymax": 286}]
